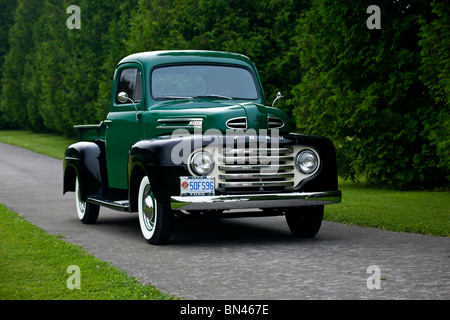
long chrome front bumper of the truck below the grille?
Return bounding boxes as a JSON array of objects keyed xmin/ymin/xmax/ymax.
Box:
[{"xmin": 171, "ymin": 190, "xmax": 342, "ymax": 210}]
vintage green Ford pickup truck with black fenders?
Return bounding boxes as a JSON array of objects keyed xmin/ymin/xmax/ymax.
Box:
[{"xmin": 63, "ymin": 51, "xmax": 341, "ymax": 244}]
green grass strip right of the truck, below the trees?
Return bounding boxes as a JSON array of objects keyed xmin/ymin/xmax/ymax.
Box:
[{"xmin": 324, "ymin": 182, "xmax": 450, "ymax": 237}]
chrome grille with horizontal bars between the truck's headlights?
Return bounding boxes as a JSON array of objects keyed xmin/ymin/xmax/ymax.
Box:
[{"xmin": 217, "ymin": 148, "xmax": 294, "ymax": 191}]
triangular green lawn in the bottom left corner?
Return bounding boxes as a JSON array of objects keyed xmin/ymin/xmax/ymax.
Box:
[{"xmin": 0, "ymin": 204, "xmax": 178, "ymax": 300}]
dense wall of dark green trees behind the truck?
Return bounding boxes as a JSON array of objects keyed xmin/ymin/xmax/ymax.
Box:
[{"xmin": 0, "ymin": 0, "xmax": 450, "ymax": 188}]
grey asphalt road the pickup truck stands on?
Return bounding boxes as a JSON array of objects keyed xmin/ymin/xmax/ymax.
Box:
[{"xmin": 0, "ymin": 143, "xmax": 450, "ymax": 300}]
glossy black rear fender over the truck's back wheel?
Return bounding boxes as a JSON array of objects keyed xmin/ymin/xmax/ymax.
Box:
[{"xmin": 63, "ymin": 141, "xmax": 108, "ymax": 201}]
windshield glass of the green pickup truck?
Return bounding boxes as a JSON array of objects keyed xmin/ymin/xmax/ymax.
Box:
[{"xmin": 151, "ymin": 65, "xmax": 259, "ymax": 100}]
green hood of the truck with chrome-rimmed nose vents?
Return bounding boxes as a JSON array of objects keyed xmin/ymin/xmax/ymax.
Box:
[{"xmin": 146, "ymin": 99, "xmax": 289, "ymax": 135}]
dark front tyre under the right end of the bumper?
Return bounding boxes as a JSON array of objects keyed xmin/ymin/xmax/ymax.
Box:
[{"xmin": 286, "ymin": 206, "xmax": 323, "ymax": 238}]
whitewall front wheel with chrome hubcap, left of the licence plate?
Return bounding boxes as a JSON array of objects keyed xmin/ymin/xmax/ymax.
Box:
[{"xmin": 138, "ymin": 176, "xmax": 173, "ymax": 244}]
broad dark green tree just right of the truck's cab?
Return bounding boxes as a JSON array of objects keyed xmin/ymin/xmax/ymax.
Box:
[{"xmin": 289, "ymin": 0, "xmax": 446, "ymax": 188}]
